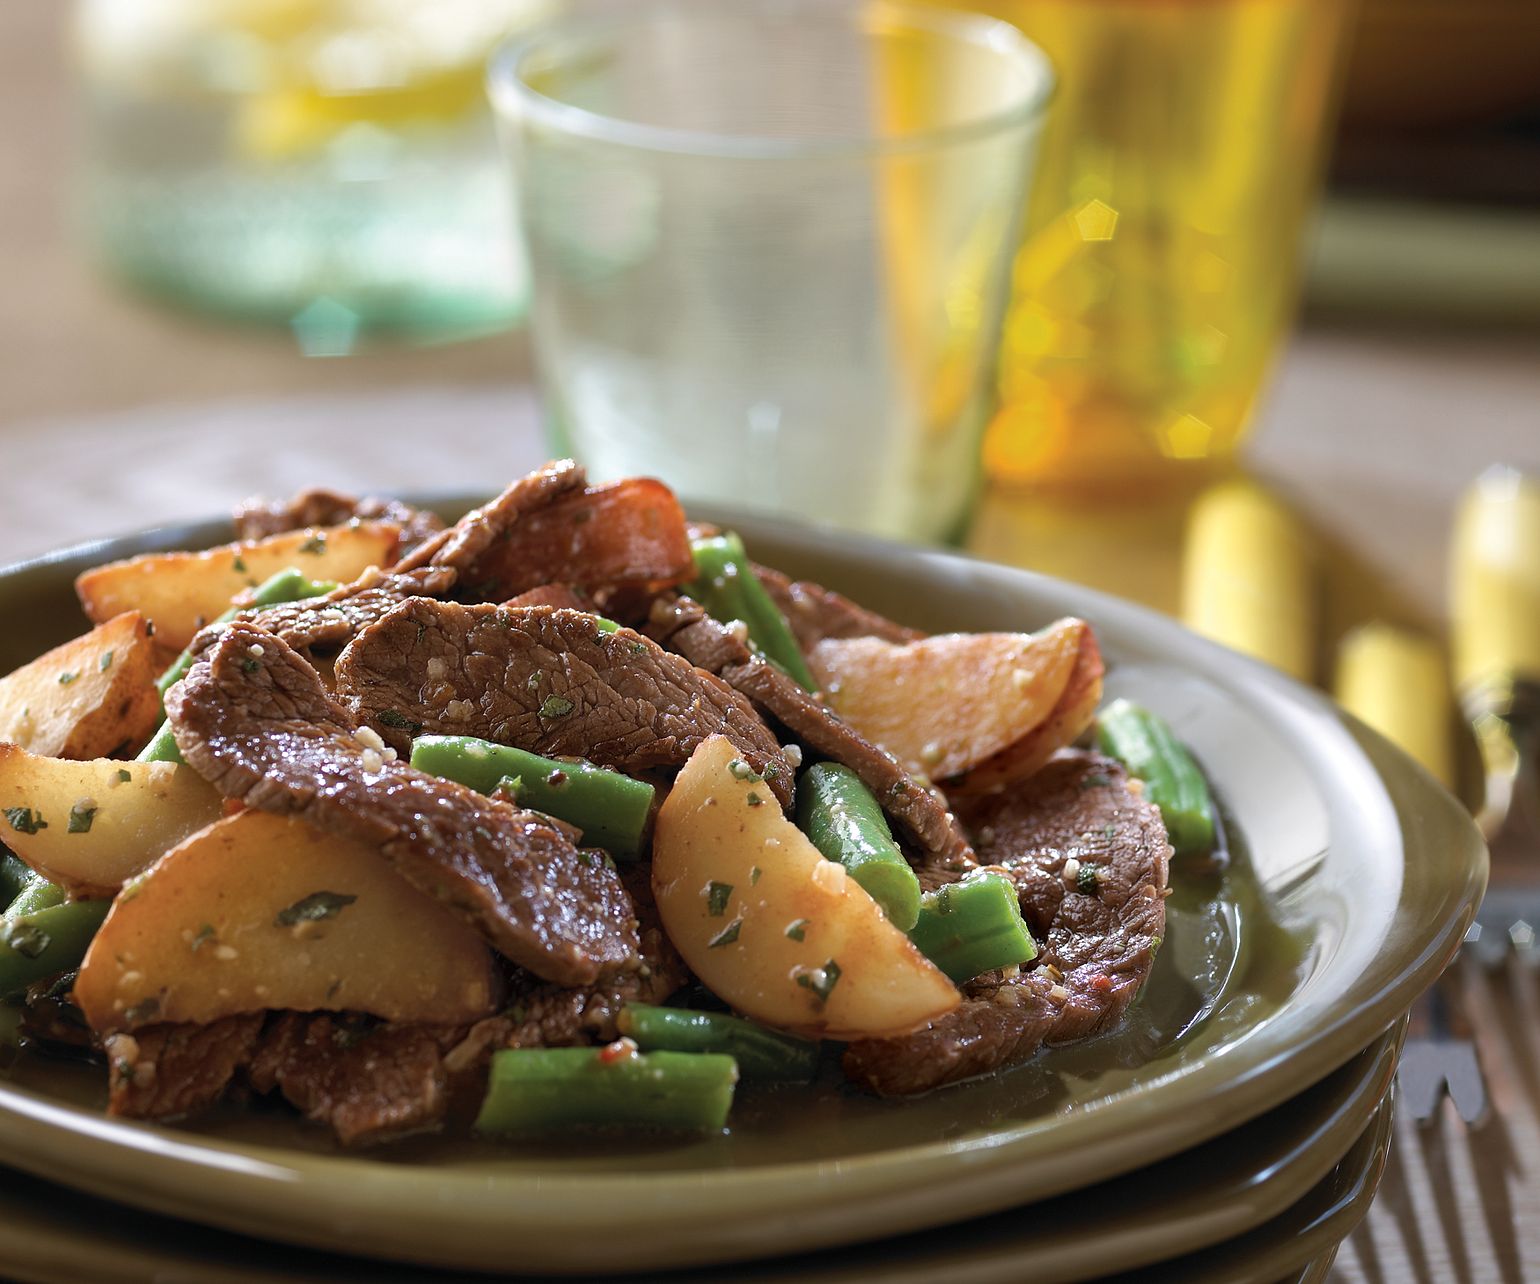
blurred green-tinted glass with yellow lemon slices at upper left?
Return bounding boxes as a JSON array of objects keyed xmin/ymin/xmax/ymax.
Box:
[{"xmin": 75, "ymin": 0, "xmax": 553, "ymax": 344}]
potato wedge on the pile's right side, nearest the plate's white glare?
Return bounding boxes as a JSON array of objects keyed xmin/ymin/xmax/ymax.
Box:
[{"xmin": 809, "ymin": 619, "xmax": 1087, "ymax": 781}]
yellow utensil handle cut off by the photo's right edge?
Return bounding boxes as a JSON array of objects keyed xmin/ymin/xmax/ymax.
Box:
[{"xmin": 1449, "ymin": 468, "xmax": 1540, "ymax": 696}]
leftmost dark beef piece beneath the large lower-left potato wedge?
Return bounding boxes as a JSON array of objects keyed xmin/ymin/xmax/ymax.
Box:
[{"xmin": 106, "ymin": 1011, "xmax": 263, "ymax": 1119}]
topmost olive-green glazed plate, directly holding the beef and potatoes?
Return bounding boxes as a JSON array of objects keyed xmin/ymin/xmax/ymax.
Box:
[{"xmin": 0, "ymin": 501, "xmax": 1486, "ymax": 1272}]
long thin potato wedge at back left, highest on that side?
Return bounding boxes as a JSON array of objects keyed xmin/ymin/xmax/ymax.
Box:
[{"xmin": 75, "ymin": 522, "xmax": 400, "ymax": 651}]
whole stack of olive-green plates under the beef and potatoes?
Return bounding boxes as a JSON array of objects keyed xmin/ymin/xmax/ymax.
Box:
[{"xmin": 0, "ymin": 514, "xmax": 1486, "ymax": 1284}]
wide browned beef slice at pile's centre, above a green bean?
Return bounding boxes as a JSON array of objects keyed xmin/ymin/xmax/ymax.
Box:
[{"xmin": 337, "ymin": 599, "xmax": 792, "ymax": 804}]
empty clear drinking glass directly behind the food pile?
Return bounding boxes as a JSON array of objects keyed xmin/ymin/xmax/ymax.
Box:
[{"xmin": 491, "ymin": 0, "xmax": 1052, "ymax": 540}]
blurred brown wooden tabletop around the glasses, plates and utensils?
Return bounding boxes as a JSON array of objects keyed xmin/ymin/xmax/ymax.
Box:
[{"xmin": 0, "ymin": 3, "xmax": 1540, "ymax": 1279}]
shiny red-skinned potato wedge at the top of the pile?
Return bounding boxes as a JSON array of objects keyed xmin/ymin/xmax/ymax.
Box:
[{"xmin": 462, "ymin": 477, "xmax": 695, "ymax": 600}]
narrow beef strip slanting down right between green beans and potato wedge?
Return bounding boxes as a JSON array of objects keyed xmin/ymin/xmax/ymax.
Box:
[{"xmin": 647, "ymin": 597, "xmax": 975, "ymax": 874}]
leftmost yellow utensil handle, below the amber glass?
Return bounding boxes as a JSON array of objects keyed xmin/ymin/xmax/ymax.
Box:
[{"xmin": 1181, "ymin": 482, "xmax": 1318, "ymax": 682}]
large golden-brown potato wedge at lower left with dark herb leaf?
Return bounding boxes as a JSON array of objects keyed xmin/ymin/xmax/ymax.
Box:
[{"xmin": 75, "ymin": 811, "xmax": 496, "ymax": 1035}]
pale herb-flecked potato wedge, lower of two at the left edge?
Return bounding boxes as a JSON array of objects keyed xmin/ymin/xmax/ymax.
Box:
[{"xmin": 0, "ymin": 744, "xmax": 223, "ymax": 898}]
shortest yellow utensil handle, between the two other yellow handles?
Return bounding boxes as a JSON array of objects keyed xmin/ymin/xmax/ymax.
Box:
[{"xmin": 1334, "ymin": 624, "xmax": 1454, "ymax": 788}]
